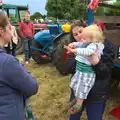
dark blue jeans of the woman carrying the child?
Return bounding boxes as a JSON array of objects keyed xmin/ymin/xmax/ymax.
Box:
[{"xmin": 69, "ymin": 89, "xmax": 106, "ymax": 120}]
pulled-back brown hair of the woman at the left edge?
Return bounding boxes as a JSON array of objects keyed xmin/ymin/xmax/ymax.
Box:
[{"xmin": 0, "ymin": 11, "xmax": 9, "ymax": 29}]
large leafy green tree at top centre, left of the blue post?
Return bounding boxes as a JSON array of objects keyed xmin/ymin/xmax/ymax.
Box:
[{"xmin": 45, "ymin": 0, "xmax": 88, "ymax": 19}]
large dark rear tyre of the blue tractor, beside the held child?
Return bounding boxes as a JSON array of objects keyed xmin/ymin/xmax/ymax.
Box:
[{"xmin": 52, "ymin": 34, "xmax": 71, "ymax": 75}]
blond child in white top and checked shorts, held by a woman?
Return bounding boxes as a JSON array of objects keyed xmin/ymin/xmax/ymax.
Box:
[{"xmin": 64, "ymin": 25, "xmax": 104, "ymax": 114}]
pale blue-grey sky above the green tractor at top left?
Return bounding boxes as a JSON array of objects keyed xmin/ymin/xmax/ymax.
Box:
[{"xmin": 2, "ymin": 0, "xmax": 47, "ymax": 14}]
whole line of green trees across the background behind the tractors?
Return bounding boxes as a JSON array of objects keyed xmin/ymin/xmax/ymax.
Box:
[{"xmin": 31, "ymin": 0, "xmax": 120, "ymax": 20}]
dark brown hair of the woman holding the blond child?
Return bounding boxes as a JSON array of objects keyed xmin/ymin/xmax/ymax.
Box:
[{"xmin": 70, "ymin": 20, "xmax": 87, "ymax": 41}]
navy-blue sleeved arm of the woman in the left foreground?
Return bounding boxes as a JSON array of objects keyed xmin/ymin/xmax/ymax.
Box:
[{"xmin": 2, "ymin": 57, "xmax": 38, "ymax": 96}]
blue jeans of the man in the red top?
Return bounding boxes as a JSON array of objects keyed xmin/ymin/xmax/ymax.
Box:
[{"xmin": 23, "ymin": 38, "xmax": 33, "ymax": 61}]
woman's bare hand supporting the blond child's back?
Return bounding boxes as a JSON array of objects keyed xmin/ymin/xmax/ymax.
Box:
[{"xmin": 88, "ymin": 49, "xmax": 100, "ymax": 65}]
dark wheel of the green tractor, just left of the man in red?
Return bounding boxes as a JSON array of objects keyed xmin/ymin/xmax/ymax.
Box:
[{"xmin": 16, "ymin": 36, "xmax": 24, "ymax": 55}]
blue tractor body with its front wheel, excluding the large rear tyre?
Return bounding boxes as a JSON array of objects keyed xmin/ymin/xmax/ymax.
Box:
[{"xmin": 31, "ymin": 24, "xmax": 68, "ymax": 63}]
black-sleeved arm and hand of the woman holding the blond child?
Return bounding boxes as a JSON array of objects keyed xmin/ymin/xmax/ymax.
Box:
[{"xmin": 91, "ymin": 40, "xmax": 117, "ymax": 78}]
